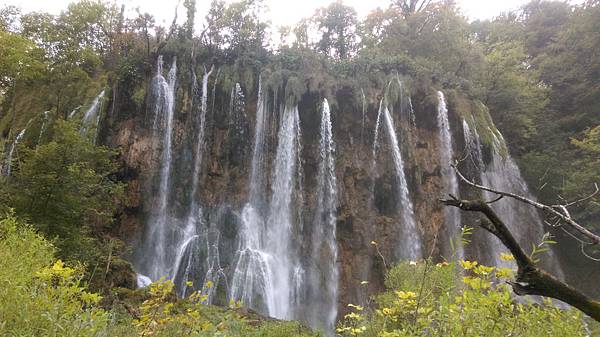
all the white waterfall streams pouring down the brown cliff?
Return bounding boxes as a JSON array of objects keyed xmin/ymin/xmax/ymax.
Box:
[{"xmin": 118, "ymin": 57, "xmax": 568, "ymax": 332}]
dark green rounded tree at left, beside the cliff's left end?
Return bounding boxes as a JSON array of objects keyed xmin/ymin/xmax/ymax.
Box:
[{"xmin": 1, "ymin": 121, "xmax": 123, "ymax": 262}]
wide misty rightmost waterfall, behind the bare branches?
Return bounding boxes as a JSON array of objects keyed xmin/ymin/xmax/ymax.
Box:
[{"xmin": 463, "ymin": 115, "xmax": 563, "ymax": 278}]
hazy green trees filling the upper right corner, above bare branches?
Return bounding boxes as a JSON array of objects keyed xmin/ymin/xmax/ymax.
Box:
[{"xmin": 473, "ymin": 1, "xmax": 600, "ymax": 229}]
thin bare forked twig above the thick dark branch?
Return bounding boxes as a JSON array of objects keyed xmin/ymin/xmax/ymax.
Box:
[{"xmin": 450, "ymin": 163, "xmax": 600, "ymax": 245}]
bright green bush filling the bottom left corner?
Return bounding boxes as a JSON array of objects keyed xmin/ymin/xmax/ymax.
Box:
[{"xmin": 0, "ymin": 215, "xmax": 109, "ymax": 336}]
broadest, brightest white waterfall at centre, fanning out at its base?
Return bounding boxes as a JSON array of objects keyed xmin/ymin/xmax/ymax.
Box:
[{"xmin": 230, "ymin": 101, "xmax": 304, "ymax": 319}]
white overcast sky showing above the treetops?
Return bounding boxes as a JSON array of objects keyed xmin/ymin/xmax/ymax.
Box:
[{"xmin": 0, "ymin": 0, "xmax": 552, "ymax": 26}]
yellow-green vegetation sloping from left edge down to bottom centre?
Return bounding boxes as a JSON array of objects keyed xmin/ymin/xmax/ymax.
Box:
[{"xmin": 0, "ymin": 214, "xmax": 324, "ymax": 337}]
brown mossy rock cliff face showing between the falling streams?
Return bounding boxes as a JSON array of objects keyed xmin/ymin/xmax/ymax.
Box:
[{"xmin": 101, "ymin": 55, "xmax": 564, "ymax": 328}]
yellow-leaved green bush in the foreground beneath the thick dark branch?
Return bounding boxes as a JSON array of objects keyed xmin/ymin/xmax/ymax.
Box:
[{"xmin": 337, "ymin": 254, "xmax": 586, "ymax": 337}]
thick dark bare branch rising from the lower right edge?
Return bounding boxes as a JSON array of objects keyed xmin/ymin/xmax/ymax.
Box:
[{"xmin": 440, "ymin": 197, "xmax": 600, "ymax": 322}]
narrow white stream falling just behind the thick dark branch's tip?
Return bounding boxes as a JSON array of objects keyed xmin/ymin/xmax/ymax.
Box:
[{"xmin": 437, "ymin": 91, "xmax": 464, "ymax": 259}]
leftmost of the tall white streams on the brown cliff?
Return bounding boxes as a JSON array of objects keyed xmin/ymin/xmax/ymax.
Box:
[{"xmin": 143, "ymin": 56, "xmax": 177, "ymax": 280}]
